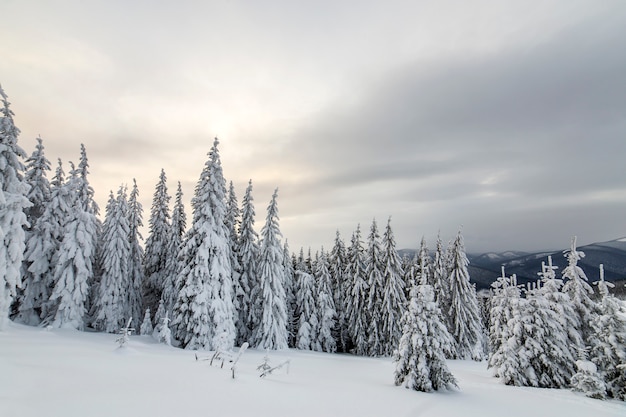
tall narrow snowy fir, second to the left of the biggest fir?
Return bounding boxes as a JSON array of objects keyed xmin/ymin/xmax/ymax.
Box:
[{"xmin": 143, "ymin": 169, "xmax": 171, "ymax": 322}]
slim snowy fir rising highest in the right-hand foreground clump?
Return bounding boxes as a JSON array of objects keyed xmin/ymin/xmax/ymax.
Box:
[{"xmin": 563, "ymin": 236, "xmax": 598, "ymax": 344}]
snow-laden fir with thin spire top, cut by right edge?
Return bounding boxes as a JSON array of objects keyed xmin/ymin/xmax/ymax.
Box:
[{"xmin": 589, "ymin": 265, "xmax": 626, "ymax": 401}]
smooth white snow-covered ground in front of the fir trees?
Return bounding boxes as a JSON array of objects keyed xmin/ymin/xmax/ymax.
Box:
[{"xmin": 0, "ymin": 324, "xmax": 626, "ymax": 417}]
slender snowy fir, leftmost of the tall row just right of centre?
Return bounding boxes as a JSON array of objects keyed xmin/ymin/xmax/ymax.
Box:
[{"xmin": 329, "ymin": 230, "xmax": 350, "ymax": 352}]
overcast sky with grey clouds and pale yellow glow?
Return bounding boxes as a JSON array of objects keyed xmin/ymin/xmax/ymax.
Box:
[{"xmin": 0, "ymin": 0, "xmax": 626, "ymax": 252}]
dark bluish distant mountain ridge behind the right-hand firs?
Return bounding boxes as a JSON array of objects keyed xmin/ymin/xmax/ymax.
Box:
[{"xmin": 399, "ymin": 238, "xmax": 626, "ymax": 294}]
